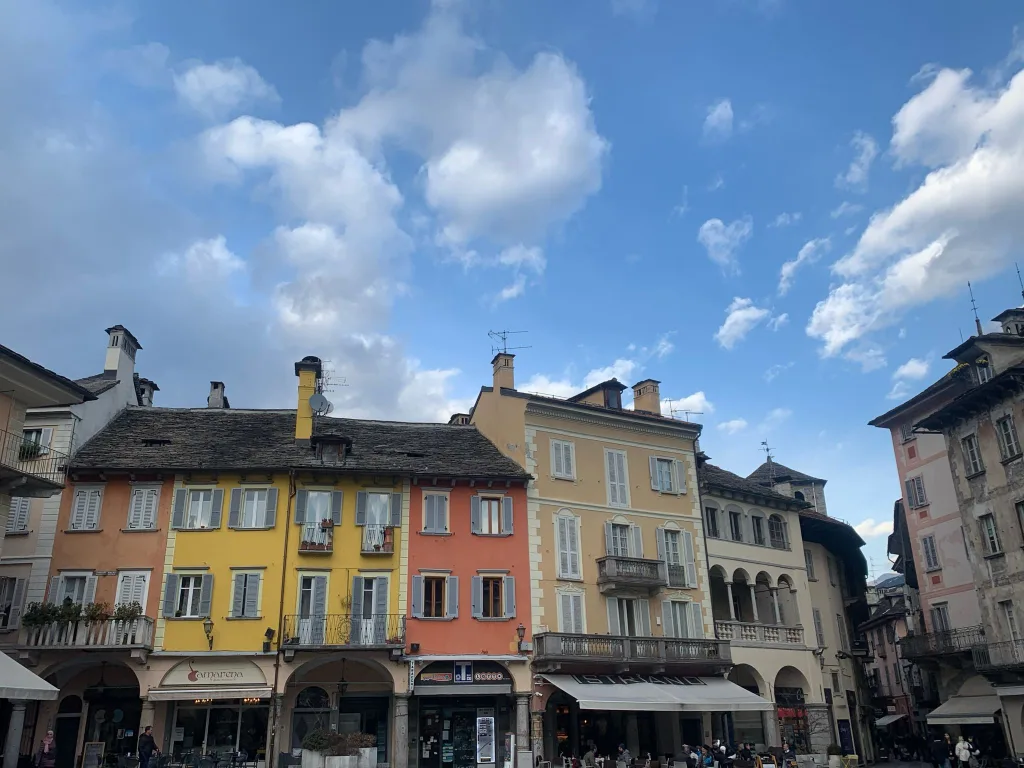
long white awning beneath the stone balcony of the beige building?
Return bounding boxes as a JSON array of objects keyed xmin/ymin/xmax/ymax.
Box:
[{"xmin": 543, "ymin": 675, "xmax": 774, "ymax": 712}]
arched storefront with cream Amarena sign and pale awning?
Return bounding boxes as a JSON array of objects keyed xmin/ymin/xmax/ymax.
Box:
[{"xmin": 150, "ymin": 658, "xmax": 270, "ymax": 761}]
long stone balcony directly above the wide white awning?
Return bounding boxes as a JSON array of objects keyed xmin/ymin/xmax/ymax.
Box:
[{"xmin": 534, "ymin": 632, "xmax": 732, "ymax": 674}]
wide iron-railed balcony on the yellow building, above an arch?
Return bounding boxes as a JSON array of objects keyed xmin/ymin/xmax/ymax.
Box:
[{"xmin": 282, "ymin": 613, "xmax": 406, "ymax": 651}]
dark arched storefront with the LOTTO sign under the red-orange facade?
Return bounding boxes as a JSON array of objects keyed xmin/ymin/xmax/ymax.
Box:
[{"xmin": 410, "ymin": 660, "xmax": 515, "ymax": 768}]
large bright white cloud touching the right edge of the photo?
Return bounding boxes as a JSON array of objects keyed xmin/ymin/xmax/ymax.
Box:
[{"xmin": 807, "ymin": 46, "xmax": 1024, "ymax": 356}]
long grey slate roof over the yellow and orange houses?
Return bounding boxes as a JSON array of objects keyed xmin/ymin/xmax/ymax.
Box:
[{"xmin": 72, "ymin": 406, "xmax": 529, "ymax": 480}]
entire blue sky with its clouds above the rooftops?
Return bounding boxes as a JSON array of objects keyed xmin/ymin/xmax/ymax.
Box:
[{"xmin": 0, "ymin": 0, "xmax": 1024, "ymax": 570}]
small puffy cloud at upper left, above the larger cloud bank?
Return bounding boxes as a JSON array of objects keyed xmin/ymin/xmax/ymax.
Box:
[{"xmin": 174, "ymin": 58, "xmax": 281, "ymax": 120}]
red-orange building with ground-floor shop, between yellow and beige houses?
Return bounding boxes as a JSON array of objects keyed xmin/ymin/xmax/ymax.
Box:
[{"xmin": 407, "ymin": 462, "xmax": 532, "ymax": 768}]
